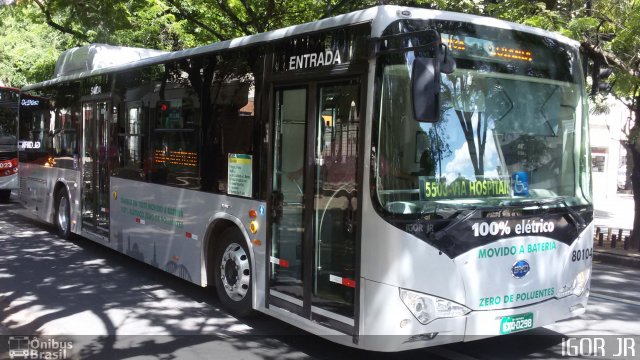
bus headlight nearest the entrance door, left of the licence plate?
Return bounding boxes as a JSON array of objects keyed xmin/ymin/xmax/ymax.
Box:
[{"xmin": 400, "ymin": 288, "xmax": 471, "ymax": 324}]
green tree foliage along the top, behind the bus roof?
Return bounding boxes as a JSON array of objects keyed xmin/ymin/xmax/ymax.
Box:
[{"xmin": 0, "ymin": 0, "xmax": 640, "ymax": 99}]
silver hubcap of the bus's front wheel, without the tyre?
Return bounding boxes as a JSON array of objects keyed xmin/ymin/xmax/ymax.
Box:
[{"xmin": 220, "ymin": 243, "xmax": 251, "ymax": 301}]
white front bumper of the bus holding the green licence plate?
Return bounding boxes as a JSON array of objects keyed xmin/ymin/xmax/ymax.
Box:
[{"xmin": 357, "ymin": 279, "xmax": 589, "ymax": 352}]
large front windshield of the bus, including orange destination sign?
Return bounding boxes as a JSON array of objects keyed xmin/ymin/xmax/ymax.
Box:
[{"xmin": 372, "ymin": 21, "xmax": 591, "ymax": 216}]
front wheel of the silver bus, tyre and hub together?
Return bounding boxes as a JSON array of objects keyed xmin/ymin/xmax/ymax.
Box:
[{"xmin": 214, "ymin": 228, "xmax": 252, "ymax": 316}]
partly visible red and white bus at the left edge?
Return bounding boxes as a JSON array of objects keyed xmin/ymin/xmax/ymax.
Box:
[{"xmin": 0, "ymin": 86, "xmax": 20, "ymax": 202}]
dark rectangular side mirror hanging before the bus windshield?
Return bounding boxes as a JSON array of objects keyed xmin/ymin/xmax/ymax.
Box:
[{"xmin": 411, "ymin": 56, "xmax": 440, "ymax": 122}]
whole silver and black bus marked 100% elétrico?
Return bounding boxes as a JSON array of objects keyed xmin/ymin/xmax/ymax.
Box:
[{"xmin": 19, "ymin": 6, "xmax": 593, "ymax": 351}]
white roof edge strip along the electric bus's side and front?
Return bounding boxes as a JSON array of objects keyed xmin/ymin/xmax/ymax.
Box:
[{"xmin": 23, "ymin": 5, "xmax": 580, "ymax": 91}]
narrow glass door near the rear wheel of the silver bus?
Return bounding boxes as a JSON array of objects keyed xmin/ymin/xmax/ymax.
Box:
[{"xmin": 82, "ymin": 102, "xmax": 109, "ymax": 237}]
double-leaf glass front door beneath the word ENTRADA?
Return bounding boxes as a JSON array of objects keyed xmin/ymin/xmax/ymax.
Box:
[{"xmin": 269, "ymin": 81, "xmax": 360, "ymax": 334}]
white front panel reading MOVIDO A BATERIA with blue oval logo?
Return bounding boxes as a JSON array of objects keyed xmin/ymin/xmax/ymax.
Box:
[{"xmin": 455, "ymin": 225, "xmax": 593, "ymax": 310}]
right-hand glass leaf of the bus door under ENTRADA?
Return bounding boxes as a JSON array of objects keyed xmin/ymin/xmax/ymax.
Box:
[{"xmin": 312, "ymin": 83, "xmax": 360, "ymax": 323}]
